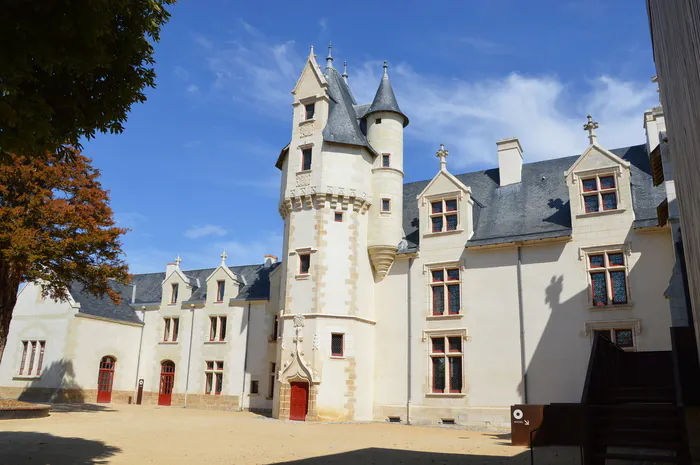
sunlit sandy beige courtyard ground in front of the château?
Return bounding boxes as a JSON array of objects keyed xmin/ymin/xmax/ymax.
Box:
[{"xmin": 0, "ymin": 404, "xmax": 579, "ymax": 465}]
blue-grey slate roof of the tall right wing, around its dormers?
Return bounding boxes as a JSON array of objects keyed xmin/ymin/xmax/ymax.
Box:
[{"xmin": 400, "ymin": 145, "xmax": 665, "ymax": 253}]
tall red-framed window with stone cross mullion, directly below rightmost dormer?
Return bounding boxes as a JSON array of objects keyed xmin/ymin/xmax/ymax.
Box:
[{"xmin": 588, "ymin": 251, "xmax": 628, "ymax": 307}]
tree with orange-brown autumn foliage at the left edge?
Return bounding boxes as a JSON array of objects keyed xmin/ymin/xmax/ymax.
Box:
[{"xmin": 0, "ymin": 150, "xmax": 130, "ymax": 360}]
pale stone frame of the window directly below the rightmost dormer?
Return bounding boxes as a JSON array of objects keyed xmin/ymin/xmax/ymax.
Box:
[{"xmin": 579, "ymin": 243, "xmax": 634, "ymax": 311}]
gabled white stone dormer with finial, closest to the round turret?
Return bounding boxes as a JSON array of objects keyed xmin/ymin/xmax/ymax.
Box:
[{"xmin": 416, "ymin": 144, "xmax": 474, "ymax": 249}]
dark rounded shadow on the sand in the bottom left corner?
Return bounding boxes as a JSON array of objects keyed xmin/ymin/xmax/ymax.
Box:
[{"xmin": 0, "ymin": 431, "xmax": 121, "ymax": 465}]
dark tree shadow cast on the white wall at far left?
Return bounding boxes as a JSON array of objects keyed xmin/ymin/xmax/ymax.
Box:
[{"xmin": 19, "ymin": 359, "xmax": 85, "ymax": 403}]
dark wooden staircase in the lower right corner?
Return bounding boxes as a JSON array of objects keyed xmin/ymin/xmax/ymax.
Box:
[{"xmin": 582, "ymin": 335, "xmax": 690, "ymax": 465}]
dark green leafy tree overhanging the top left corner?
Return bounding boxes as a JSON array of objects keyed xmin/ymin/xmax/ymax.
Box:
[{"xmin": 0, "ymin": 0, "xmax": 176, "ymax": 156}]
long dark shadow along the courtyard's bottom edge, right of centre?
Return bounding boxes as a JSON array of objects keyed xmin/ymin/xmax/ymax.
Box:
[{"xmin": 276, "ymin": 447, "xmax": 580, "ymax": 465}]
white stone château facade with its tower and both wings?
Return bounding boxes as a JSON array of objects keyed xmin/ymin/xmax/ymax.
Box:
[{"xmin": 0, "ymin": 48, "xmax": 675, "ymax": 428}]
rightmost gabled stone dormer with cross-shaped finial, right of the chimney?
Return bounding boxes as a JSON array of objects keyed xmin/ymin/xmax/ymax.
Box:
[{"xmin": 565, "ymin": 115, "xmax": 634, "ymax": 229}]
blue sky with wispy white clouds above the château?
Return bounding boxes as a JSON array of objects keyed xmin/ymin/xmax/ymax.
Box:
[{"xmin": 84, "ymin": 0, "xmax": 658, "ymax": 273}]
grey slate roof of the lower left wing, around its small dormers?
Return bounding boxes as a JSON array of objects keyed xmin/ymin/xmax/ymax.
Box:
[{"xmin": 70, "ymin": 263, "xmax": 279, "ymax": 323}]
